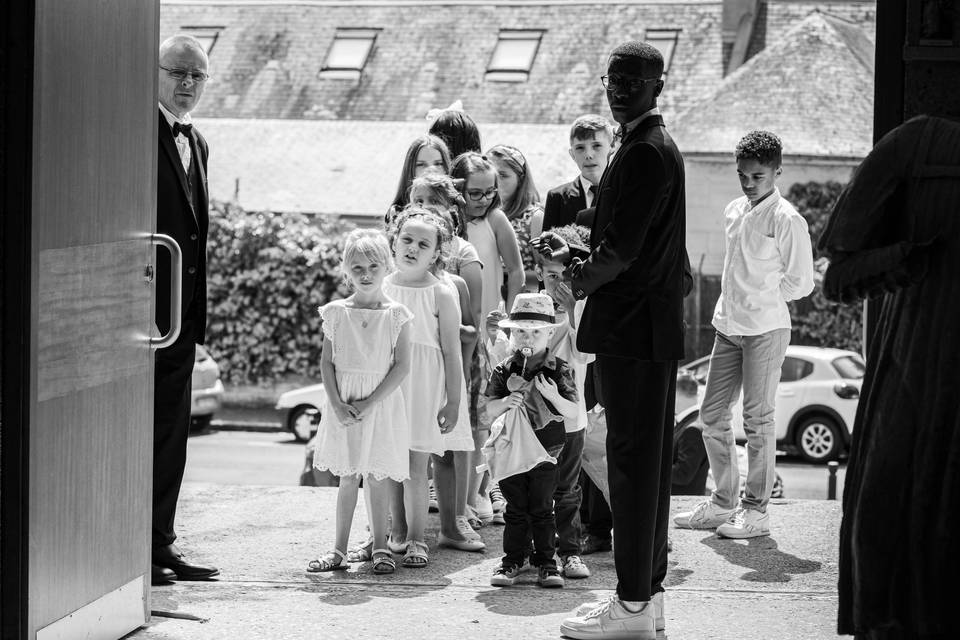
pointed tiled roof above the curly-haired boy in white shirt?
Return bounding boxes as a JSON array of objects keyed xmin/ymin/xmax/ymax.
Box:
[{"xmin": 673, "ymin": 10, "xmax": 873, "ymax": 158}]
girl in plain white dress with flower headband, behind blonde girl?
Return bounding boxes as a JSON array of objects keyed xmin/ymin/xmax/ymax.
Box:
[{"xmin": 383, "ymin": 207, "xmax": 473, "ymax": 567}]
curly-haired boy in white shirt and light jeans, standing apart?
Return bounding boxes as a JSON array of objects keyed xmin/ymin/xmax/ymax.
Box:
[{"xmin": 674, "ymin": 131, "xmax": 814, "ymax": 538}]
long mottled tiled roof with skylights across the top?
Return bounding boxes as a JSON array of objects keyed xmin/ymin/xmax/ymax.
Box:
[{"xmin": 160, "ymin": 0, "xmax": 723, "ymax": 124}]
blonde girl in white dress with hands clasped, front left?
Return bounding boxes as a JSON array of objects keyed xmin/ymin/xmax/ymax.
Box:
[{"xmin": 307, "ymin": 229, "xmax": 413, "ymax": 573}]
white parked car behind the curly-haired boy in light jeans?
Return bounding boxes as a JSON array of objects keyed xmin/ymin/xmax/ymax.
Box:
[{"xmin": 677, "ymin": 345, "xmax": 866, "ymax": 464}]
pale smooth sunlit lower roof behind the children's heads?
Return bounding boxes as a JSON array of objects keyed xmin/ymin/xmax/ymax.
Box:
[{"xmin": 196, "ymin": 118, "xmax": 577, "ymax": 215}]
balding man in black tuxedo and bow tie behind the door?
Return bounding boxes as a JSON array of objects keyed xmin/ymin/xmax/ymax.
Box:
[{"xmin": 152, "ymin": 36, "xmax": 220, "ymax": 584}]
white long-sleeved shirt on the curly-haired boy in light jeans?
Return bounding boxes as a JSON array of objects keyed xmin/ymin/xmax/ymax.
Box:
[{"xmin": 713, "ymin": 188, "xmax": 814, "ymax": 336}]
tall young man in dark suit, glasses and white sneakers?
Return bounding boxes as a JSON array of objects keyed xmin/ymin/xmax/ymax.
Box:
[{"xmin": 538, "ymin": 42, "xmax": 688, "ymax": 640}]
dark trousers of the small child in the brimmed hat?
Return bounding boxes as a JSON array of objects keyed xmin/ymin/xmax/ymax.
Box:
[{"xmin": 500, "ymin": 462, "xmax": 557, "ymax": 567}]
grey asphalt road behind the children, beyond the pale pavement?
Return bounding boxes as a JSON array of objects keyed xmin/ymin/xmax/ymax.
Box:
[{"xmin": 184, "ymin": 428, "xmax": 845, "ymax": 500}]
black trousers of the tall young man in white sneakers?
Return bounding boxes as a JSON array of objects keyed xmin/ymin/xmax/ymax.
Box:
[{"xmin": 594, "ymin": 355, "xmax": 677, "ymax": 602}]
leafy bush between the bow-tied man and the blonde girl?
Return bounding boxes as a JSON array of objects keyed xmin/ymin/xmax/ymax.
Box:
[{"xmin": 207, "ymin": 202, "xmax": 352, "ymax": 384}]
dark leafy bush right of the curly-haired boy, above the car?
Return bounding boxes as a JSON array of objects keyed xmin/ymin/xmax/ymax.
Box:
[{"xmin": 786, "ymin": 181, "xmax": 863, "ymax": 352}]
